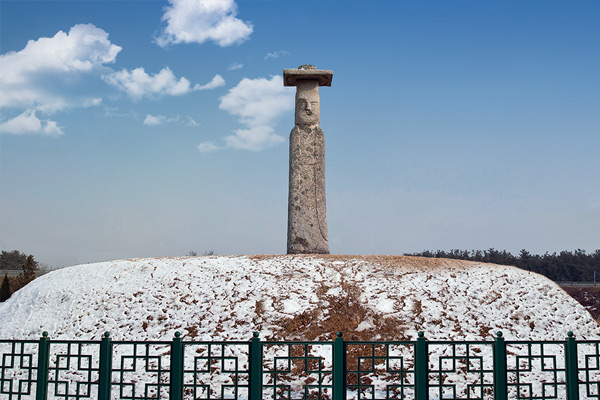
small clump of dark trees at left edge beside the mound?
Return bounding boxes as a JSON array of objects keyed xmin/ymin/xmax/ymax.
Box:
[{"xmin": 0, "ymin": 250, "xmax": 39, "ymax": 302}]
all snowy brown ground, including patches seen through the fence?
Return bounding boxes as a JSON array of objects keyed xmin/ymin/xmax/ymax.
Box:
[{"xmin": 0, "ymin": 256, "xmax": 600, "ymax": 399}]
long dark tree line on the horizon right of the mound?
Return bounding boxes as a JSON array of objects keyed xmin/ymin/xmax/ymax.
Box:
[{"xmin": 406, "ymin": 248, "xmax": 600, "ymax": 282}]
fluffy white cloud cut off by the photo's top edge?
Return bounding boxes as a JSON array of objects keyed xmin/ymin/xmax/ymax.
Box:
[{"xmin": 156, "ymin": 0, "xmax": 253, "ymax": 47}]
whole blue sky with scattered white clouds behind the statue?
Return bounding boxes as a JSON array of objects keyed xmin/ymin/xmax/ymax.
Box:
[{"xmin": 0, "ymin": 0, "xmax": 600, "ymax": 265}]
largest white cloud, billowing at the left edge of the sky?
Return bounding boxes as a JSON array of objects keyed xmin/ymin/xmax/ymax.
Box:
[{"xmin": 0, "ymin": 24, "xmax": 121, "ymax": 112}]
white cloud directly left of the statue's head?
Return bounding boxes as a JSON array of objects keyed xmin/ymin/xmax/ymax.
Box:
[{"xmin": 219, "ymin": 76, "xmax": 294, "ymax": 151}]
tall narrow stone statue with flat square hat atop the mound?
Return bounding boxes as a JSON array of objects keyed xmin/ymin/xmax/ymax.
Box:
[{"xmin": 283, "ymin": 65, "xmax": 333, "ymax": 254}]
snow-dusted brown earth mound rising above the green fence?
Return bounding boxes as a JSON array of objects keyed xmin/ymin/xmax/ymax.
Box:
[{"xmin": 0, "ymin": 256, "xmax": 600, "ymax": 340}]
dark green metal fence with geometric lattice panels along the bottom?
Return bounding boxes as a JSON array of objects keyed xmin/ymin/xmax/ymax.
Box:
[{"xmin": 0, "ymin": 332, "xmax": 600, "ymax": 400}]
